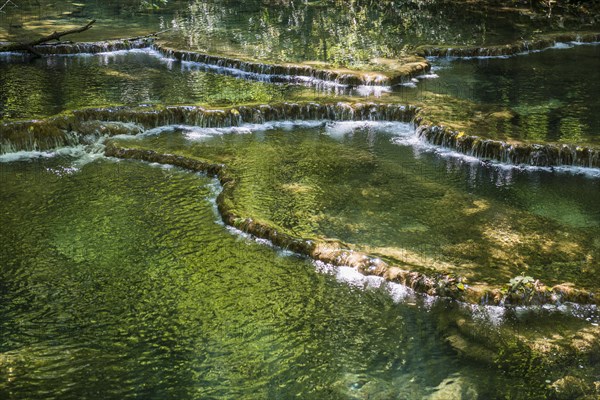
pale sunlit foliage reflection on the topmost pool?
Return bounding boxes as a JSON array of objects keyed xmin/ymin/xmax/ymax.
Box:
[{"xmin": 175, "ymin": 0, "xmax": 592, "ymax": 65}]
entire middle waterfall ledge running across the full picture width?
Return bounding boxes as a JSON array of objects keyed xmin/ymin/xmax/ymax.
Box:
[{"xmin": 0, "ymin": 102, "xmax": 600, "ymax": 168}]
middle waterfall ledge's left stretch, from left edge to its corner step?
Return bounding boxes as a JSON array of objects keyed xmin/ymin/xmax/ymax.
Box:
[{"xmin": 0, "ymin": 102, "xmax": 417, "ymax": 154}]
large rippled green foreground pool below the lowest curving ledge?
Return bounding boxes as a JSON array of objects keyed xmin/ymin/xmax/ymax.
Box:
[{"xmin": 0, "ymin": 157, "xmax": 548, "ymax": 399}]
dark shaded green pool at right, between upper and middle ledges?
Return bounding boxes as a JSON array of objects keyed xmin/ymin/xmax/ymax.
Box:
[{"xmin": 419, "ymin": 45, "xmax": 600, "ymax": 146}]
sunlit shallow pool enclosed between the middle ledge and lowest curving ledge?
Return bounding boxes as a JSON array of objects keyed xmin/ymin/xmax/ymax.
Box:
[{"xmin": 112, "ymin": 121, "xmax": 600, "ymax": 289}]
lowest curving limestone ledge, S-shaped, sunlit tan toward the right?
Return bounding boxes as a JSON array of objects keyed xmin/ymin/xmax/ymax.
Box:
[{"xmin": 105, "ymin": 144, "xmax": 598, "ymax": 305}]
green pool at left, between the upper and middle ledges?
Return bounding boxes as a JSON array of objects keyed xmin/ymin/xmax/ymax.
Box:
[{"xmin": 0, "ymin": 50, "xmax": 320, "ymax": 119}]
